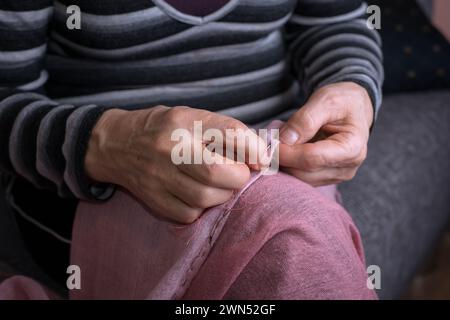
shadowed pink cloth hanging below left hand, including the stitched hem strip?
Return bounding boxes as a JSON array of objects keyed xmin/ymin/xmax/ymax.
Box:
[{"xmin": 72, "ymin": 175, "xmax": 268, "ymax": 299}]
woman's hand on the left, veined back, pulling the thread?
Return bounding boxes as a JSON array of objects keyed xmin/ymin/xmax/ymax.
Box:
[{"xmin": 85, "ymin": 106, "xmax": 266, "ymax": 224}]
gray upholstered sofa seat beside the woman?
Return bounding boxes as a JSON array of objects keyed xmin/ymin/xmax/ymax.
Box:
[{"xmin": 340, "ymin": 91, "xmax": 450, "ymax": 299}]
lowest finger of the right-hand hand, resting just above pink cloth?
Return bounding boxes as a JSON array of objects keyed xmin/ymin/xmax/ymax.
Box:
[{"xmin": 283, "ymin": 168, "xmax": 357, "ymax": 187}]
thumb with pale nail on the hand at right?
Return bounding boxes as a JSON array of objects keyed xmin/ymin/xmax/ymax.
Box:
[{"xmin": 280, "ymin": 96, "xmax": 346, "ymax": 145}]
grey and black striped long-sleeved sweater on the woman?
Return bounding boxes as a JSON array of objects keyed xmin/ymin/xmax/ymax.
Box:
[{"xmin": 0, "ymin": 0, "xmax": 383, "ymax": 200}]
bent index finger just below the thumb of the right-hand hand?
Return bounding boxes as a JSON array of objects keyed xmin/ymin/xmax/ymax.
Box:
[{"xmin": 280, "ymin": 132, "xmax": 367, "ymax": 171}]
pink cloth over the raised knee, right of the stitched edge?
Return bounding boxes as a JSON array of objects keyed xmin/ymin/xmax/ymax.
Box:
[{"xmin": 186, "ymin": 174, "xmax": 374, "ymax": 299}]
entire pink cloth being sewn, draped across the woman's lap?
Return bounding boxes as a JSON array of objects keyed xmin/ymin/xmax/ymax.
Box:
[{"xmin": 0, "ymin": 123, "xmax": 376, "ymax": 299}]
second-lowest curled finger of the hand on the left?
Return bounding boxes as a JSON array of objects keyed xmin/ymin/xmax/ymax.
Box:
[{"xmin": 167, "ymin": 172, "xmax": 233, "ymax": 209}]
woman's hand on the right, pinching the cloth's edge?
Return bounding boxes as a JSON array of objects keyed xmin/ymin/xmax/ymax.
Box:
[{"xmin": 280, "ymin": 82, "xmax": 373, "ymax": 186}]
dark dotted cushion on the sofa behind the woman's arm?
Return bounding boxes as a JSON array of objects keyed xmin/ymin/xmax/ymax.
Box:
[{"xmin": 369, "ymin": 0, "xmax": 450, "ymax": 93}]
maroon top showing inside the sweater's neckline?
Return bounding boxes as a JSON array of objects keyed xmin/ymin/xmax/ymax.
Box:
[{"xmin": 165, "ymin": 0, "xmax": 230, "ymax": 17}]
